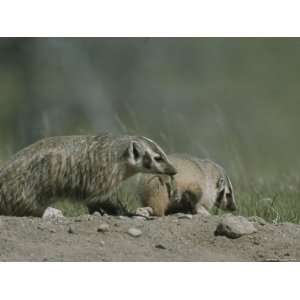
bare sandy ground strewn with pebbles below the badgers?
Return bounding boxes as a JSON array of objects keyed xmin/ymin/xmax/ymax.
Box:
[{"xmin": 0, "ymin": 215, "xmax": 300, "ymax": 261}]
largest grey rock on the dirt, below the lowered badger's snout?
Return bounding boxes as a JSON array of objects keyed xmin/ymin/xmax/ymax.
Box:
[{"xmin": 215, "ymin": 215, "xmax": 257, "ymax": 239}]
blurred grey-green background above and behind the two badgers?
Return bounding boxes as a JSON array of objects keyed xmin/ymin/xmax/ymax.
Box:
[{"xmin": 0, "ymin": 38, "xmax": 300, "ymax": 183}]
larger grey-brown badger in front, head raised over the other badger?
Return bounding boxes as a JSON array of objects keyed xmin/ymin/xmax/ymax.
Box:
[{"xmin": 0, "ymin": 134, "xmax": 176, "ymax": 216}]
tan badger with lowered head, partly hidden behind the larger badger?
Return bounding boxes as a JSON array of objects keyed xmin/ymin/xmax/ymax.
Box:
[{"xmin": 129, "ymin": 154, "xmax": 236, "ymax": 216}]
